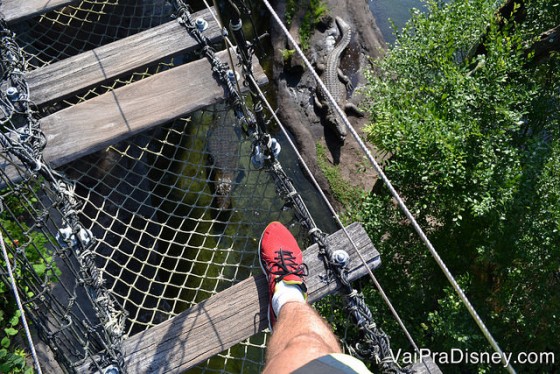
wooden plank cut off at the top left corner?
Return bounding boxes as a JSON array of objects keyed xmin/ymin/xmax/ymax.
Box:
[{"xmin": 0, "ymin": 0, "xmax": 80, "ymax": 23}]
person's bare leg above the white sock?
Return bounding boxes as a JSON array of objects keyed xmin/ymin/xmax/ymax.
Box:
[{"xmin": 263, "ymin": 302, "xmax": 341, "ymax": 374}]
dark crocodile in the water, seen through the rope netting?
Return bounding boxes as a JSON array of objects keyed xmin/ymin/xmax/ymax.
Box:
[{"xmin": 203, "ymin": 116, "xmax": 244, "ymax": 212}]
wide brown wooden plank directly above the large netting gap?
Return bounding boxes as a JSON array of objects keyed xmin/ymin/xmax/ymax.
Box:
[{"xmin": 40, "ymin": 51, "xmax": 267, "ymax": 167}]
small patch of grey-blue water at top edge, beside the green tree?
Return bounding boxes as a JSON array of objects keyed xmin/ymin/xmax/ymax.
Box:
[{"xmin": 369, "ymin": 0, "xmax": 426, "ymax": 45}]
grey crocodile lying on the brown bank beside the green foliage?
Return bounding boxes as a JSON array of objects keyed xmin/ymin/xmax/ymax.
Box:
[{"xmin": 315, "ymin": 17, "xmax": 363, "ymax": 142}]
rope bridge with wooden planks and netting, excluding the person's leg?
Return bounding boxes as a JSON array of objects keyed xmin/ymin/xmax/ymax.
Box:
[{"xmin": 0, "ymin": 0, "xmax": 437, "ymax": 372}]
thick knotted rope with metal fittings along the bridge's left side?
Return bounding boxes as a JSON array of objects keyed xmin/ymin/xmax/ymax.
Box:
[{"xmin": 0, "ymin": 21, "xmax": 126, "ymax": 372}]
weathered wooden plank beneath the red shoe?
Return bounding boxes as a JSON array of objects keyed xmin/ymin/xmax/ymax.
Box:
[{"xmin": 77, "ymin": 223, "xmax": 380, "ymax": 373}]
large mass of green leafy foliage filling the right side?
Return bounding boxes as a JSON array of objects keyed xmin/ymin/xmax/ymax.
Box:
[{"xmin": 352, "ymin": 0, "xmax": 560, "ymax": 370}]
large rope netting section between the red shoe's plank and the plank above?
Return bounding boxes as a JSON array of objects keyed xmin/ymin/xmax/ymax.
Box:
[{"xmin": 64, "ymin": 109, "xmax": 328, "ymax": 334}]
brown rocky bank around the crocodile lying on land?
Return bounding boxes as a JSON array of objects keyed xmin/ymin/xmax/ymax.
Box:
[{"xmin": 271, "ymin": 0, "xmax": 386, "ymax": 207}]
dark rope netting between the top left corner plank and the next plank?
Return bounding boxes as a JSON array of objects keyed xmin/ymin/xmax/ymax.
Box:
[{"xmin": 14, "ymin": 0, "xmax": 174, "ymax": 69}]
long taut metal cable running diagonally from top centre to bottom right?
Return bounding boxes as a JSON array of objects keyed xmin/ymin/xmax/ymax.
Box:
[{"xmin": 263, "ymin": 0, "xmax": 515, "ymax": 373}]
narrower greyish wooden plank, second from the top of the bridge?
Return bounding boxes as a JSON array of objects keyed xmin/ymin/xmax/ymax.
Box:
[{"xmin": 26, "ymin": 9, "xmax": 221, "ymax": 105}]
